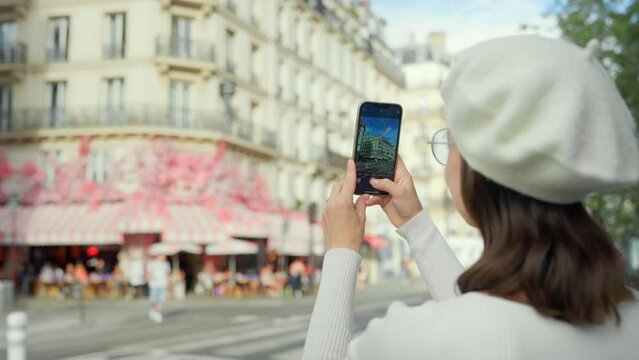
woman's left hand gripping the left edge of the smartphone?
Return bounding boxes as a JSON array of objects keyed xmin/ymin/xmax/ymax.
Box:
[{"xmin": 322, "ymin": 159, "xmax": 369, "ymax": 251}]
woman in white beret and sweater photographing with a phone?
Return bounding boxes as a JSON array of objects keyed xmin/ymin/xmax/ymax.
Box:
[{"xmin": 303, "ymin": 36, "xmax": 639, "ymax": 360}]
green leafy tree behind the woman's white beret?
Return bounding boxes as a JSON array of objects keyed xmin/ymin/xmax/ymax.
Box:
[{"xmin": 551, "ymin": 0, "xmax": 639, "ymax": 276}]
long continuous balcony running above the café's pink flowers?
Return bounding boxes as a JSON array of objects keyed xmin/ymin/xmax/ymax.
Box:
[{"xmin": 0, "ymin": 104, "xmax": 277, "ymax": 156}]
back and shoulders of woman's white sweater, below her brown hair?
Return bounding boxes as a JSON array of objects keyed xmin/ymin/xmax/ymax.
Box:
[{"xmin": 349, "ymin": 292, "xmax": 639, "ymax": 360}]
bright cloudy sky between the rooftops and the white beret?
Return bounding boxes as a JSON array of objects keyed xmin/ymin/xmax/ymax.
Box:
[{"xmin": 370, "ymin": 0, "xmax": 559, "ymax": 54}]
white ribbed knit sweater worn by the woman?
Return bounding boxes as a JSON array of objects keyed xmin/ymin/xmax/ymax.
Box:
[{"xmin": 303, "ymin": 212, "xmax": 639, "ymax": 360}]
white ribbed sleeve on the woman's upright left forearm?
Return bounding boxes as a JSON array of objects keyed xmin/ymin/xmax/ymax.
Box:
[{"xmin": 302, "ymin": 248, "xmax": 361, "ymax": 360}]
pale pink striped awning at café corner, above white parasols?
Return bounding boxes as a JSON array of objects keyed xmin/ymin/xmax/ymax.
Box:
[{"xmin": 162, "ymin": 205, "xmax": 230, "ymax": 244}]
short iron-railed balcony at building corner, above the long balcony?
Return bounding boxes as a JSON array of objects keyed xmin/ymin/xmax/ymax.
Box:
[{"xmin": 155, "ymin": 36, "xmax": 215, "ymax": 75}]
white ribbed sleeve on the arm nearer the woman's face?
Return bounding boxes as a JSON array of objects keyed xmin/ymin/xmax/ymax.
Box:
[{"xmin": 397, "ymin": 210, "xmax": 464, "ymax": 301}]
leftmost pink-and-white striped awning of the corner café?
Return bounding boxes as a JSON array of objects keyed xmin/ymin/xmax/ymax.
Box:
[{"xmin": 0, "ymin": 204, "xmax": 122, "ymax": 246}]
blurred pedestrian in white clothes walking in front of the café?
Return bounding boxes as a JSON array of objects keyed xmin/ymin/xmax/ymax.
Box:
[{"xmin": 146, "ymin": 255, "xmax": 171, "ymax": 323}]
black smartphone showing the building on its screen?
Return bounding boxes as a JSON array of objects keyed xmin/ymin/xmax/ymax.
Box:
[{"xmin": 353, "ymin": 101, "xmax": 402, "ymax": 195}]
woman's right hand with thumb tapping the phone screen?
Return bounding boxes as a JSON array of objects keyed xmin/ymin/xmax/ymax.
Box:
[{"xmin": 366, "ymin": 155, "xmax": 423, "ymax": 227}]
